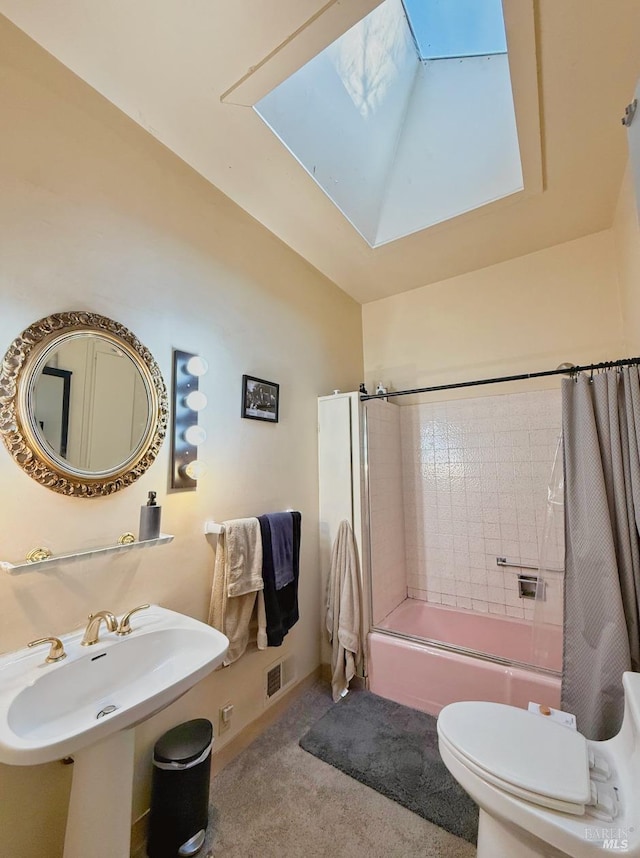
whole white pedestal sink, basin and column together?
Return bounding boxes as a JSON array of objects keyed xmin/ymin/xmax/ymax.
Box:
[{"xmin": 0, "ymin": 605, "xmax": 229, "ymax": 858}]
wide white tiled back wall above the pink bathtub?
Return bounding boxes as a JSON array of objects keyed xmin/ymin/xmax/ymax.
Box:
[{"xmin": 402, "ymin": 390, "xmax": 564, "ymax": 618}]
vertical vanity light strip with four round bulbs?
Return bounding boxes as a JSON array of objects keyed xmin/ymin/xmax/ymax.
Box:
[{"xmin": 171, "ymin": 349, "xmax": 208, "ymax": 489}]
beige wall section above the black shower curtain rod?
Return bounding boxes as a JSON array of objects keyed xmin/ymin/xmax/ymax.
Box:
[{"xmin": 362, "ymin": 230, "xmax": 625, "ymax": 396}]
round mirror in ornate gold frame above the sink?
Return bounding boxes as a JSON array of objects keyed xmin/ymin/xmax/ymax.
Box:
[{"xmin": 0, "ymin": 311, "xmax": 168, "ymax": 497}]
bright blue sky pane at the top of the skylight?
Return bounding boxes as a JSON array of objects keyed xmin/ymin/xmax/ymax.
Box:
[{"xmin": 402, "ymin": 0, "xmax": 507, "ymax": 60}]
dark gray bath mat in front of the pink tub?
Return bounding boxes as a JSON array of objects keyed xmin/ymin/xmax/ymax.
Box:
[{"xmin": 300, "ymin": 691, "xmax": 478, "ymax": 843}]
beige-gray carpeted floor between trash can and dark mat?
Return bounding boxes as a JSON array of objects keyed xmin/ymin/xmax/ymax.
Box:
[{"xmin": 200, "ymin": 683, "xmax": 476, "ymax": 858}]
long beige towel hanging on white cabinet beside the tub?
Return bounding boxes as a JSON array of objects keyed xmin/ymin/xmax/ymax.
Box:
[{"xmin": 327, "ymin": 521, "xmax": 362, "ymax": 703}]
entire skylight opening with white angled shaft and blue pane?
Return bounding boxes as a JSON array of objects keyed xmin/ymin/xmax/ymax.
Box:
[{"xmin": 255, "ymin": 0, "xmax": 524, "ymax": 247}]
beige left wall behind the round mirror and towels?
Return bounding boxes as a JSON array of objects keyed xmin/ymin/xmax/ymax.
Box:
[{"xmin": 0, "ymin": 19, "xmax": 362, "ymax": 858}]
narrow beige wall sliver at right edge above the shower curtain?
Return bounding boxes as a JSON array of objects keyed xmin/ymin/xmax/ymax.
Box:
[{"xmin": 612, "ymin": 164, "xmax": 640, "ymax": 357}]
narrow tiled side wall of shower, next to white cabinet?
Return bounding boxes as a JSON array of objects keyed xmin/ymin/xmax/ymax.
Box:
[{"xmin": 366, "ymin": 399, "xmax": 407, "ymax": 623}]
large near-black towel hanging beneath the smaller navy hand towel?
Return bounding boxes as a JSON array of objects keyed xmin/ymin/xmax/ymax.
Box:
[{"xmin": 258, "ymin": 512, "xmax": 302, "ymax": 646}]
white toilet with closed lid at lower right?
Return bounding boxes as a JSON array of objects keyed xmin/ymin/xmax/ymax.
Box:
[{"xmin": 438, "ymin": 672, "xmax": 640, "ymax": 858}]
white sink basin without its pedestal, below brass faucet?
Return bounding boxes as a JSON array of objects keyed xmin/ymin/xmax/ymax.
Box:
[{"xmin": 0, "ymin": 605, "xmax": 229, "ymax": 766}]
